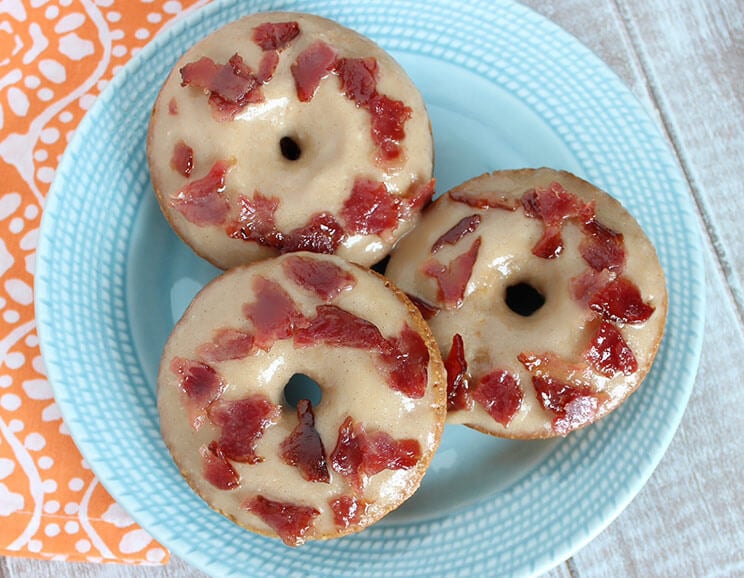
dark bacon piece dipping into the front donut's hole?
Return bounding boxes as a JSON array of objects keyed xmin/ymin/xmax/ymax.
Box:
[{"xmin": 279, "ymin": 399, "xmax": 331, "ymax": 484}]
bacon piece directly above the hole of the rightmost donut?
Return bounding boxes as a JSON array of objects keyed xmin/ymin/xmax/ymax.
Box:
[{"xmin": 521, "ymin": 182, "xmax": 594, "ymax": 259}]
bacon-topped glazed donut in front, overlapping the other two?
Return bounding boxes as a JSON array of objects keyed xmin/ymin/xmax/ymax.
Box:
[{"xmin": 157, "ymin": 251, "xmax": 446, "ymax": 546}]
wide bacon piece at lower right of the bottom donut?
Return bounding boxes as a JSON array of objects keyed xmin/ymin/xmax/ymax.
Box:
[{"xmin": 330, "ymin": 416, "xmax": 421, "ymax": 491}]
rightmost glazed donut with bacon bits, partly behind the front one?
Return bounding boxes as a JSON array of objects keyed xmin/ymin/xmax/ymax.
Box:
[{"xmin": 385, "ymin": 168, "xmax": 667, "ymax": 439}]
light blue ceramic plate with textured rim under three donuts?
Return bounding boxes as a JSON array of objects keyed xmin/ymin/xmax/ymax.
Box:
[{"xmin": 36, "ymin": 0, "xmax": 704, "ymax": 578}]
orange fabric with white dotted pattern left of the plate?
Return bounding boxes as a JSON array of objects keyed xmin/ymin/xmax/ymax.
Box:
[{"xmin": 0, "ymin": 0, "xmax": 208, "ymax": 564}]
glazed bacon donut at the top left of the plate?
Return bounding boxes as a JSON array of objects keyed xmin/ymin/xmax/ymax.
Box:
[{"xmin": 147, "ymin": 12, "xmax": 434, "ymax": 269}]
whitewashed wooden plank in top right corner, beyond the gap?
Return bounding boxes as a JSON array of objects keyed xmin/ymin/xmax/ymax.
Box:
[{"xmin": 618, "ymin": 0, "xmax": 744, "ymax": 321}]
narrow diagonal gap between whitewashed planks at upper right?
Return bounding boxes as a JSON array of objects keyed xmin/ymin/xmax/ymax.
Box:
[{"xmin": 612, "ymin": 0, "xmax": 744, "ymax": 326}]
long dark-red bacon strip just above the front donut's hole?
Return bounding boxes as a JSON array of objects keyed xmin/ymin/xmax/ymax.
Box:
[{"xmin": 294, "ymin": 305, "xmax": 387, "ymax": 352}]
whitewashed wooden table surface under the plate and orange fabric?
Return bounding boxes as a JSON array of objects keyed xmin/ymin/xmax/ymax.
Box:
[{"xmin": 0, "ymin": 0, "xmax": 744, "ymax": 578}]
